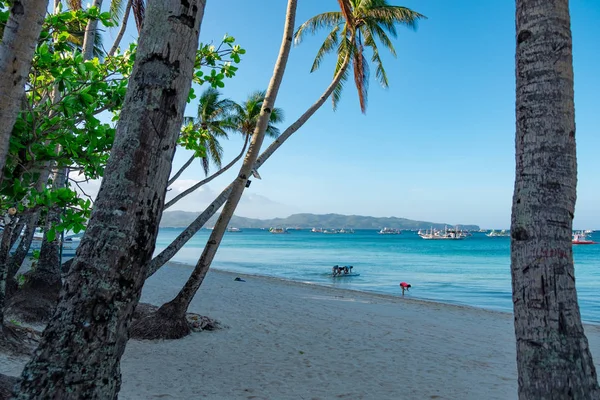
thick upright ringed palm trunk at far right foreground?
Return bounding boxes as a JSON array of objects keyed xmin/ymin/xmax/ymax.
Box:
[{"xmin": 511, "ymin": 0, "xmax": 600, "ymax": 400}]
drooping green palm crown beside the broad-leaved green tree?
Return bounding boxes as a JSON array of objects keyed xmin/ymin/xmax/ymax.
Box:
[{"xmin": 183, "ymin": 87, "xmax": 237, "ymax": 175}]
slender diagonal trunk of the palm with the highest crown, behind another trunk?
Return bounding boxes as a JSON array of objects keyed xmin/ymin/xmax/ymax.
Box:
[{"xmin": 148, "ymin": 53, "xmax": 350, "ymax": 277}]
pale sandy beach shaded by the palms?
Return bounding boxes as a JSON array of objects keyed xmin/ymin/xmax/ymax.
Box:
[{"xmin": 0, "ymin": 266, "xmax": 600, "ymax": 400}]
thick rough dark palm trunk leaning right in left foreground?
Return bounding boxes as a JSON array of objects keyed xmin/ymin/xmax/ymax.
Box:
[{"xmin": 17, "ymin": 0, "xmax": 205, "ymax": 399}]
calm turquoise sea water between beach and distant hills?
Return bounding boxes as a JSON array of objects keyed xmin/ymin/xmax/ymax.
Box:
[{"xmin": 157, "ymin": 228, "xmax": 600, "ymax": 323}]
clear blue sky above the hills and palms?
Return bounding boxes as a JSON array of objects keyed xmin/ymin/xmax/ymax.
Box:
[{"xmin": 96, "ymin": 0, "xmax": 600, "ymax": 228}]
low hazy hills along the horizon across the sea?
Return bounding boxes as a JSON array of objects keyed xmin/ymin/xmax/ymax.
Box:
[{"xmin": 160, "ymin": 211, "xmax": 479, "ymax": 230}]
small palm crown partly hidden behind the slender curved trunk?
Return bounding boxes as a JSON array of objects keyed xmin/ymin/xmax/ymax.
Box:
[{"xmin": 231, "ymin": 90, "xmax": 283, "ymax": 138}]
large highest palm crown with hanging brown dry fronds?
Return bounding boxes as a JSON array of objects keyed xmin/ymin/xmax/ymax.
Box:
[{"xmin": 294, "ymin": 0, "xmax": 426, "ymax": 113}]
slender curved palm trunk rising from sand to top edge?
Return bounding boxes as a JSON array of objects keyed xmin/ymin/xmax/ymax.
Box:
[{"xmin": 155, "ymin": 0, "xmax": 297, "ymax": 318}]
